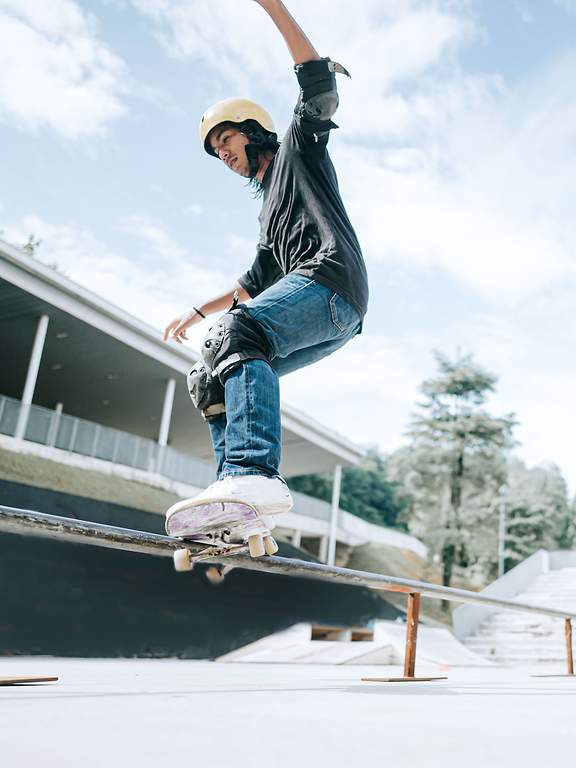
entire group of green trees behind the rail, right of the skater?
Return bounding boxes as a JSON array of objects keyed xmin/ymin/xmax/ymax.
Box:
[{"xmin": 290, "ymin": 353, "xmax": 576, "ymax": 586}]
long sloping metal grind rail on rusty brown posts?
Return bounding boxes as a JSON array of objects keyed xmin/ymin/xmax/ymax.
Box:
[{"xmin": 0, "ymin": 506, "xmax": 576, "ymax": 682}]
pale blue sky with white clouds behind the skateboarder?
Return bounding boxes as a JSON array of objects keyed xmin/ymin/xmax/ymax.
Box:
[{"xmin": 0, "ymin": 0, "xmax": 576, "ymax": 491}]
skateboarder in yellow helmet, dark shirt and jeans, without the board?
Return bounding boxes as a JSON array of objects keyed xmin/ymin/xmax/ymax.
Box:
[{"xmin": 164, "ymin": 0, "xmax": 368, "ymax": 540}]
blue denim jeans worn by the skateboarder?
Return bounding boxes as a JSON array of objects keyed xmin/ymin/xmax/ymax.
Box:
[{"xmin": 209, "ymin": 274, "xmax": 361, "ymax": 479}]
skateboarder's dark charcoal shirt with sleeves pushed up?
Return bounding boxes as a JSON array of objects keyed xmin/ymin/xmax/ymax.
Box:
[{"xmin": 239, "ymin": 65, "xmax": 368, "ymax": 318}]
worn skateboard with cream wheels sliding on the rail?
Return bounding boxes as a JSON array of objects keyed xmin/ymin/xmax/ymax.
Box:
[{"xmin": 166, "ymin": 501, "xmax": 278, "ymax": 571}]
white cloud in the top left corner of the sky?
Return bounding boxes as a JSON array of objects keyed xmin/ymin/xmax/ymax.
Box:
[{"xmin": 0, "ymin": 0, "xmax": 126, "ymax": 139}]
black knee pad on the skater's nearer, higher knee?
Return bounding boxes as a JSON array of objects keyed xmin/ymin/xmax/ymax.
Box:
[{"xmin": 202, "ymin": 304, "xmax": 270, "ymax": 384}]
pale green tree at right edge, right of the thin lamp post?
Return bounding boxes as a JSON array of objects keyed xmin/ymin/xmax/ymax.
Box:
[{"xmin": 505, "ymin": 458, "xmax": 574, "ymax": 570}]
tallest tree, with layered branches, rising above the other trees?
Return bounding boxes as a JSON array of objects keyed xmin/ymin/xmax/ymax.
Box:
[{"xmin": 388, "ymin": 353, "xmax": 515, "ymax": 586}]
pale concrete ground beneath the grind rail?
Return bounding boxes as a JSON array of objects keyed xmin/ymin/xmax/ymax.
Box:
[{"xmin": 0, "ymin": 657, "xmax": 576, "ymax": 768}]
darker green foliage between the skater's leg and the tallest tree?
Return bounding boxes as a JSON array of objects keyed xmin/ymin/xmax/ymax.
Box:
[{"xmin": 290, "ymin": 450, "xmax": 407, "ymax": 530}]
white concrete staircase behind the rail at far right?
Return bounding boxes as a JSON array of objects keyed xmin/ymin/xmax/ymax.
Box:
[{"xmin": 464, "ymin": 567, "xmax": 576, "ymax": 664}]
